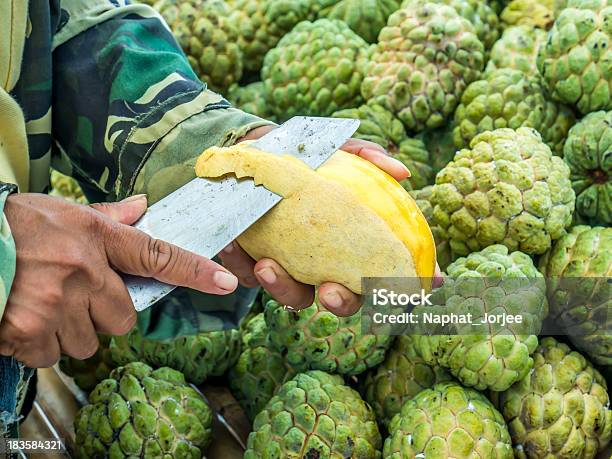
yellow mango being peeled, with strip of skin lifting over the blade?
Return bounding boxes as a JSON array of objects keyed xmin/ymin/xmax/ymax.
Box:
[{"xmin": 196, "ymin": 143, "xmax": 435, "ymax": 294}]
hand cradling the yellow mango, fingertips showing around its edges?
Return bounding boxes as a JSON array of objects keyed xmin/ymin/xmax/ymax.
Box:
[{"xmin": 224, "ymin": 126, "xmax": 441, "ymax": 316}]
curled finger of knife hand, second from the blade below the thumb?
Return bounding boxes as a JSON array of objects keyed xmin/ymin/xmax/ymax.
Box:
[{"xmin": 57, "ymin": 315, "xmax": 100, "ymax": 360}]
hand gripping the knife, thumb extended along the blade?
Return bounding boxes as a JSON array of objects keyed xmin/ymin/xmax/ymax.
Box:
[{"xmin": 0, "ymin": 194, "xmax": 238, "ymax": 368}]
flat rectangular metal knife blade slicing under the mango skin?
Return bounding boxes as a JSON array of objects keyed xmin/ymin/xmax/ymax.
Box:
[{"xmin": 123, "ymin": 116, "xmax": 359, "ymax": 311}]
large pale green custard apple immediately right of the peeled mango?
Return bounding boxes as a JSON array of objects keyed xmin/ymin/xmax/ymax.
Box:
[{"xmin": 432, "ymin": 128, "xmax": 575, "ymax": 256}]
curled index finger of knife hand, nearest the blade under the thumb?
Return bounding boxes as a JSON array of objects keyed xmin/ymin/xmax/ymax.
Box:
[{"xmin": 89, "ymin": 270, "xmax": 136, "ymax": 336}]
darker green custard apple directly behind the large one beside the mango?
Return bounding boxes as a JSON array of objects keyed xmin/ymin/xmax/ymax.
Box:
[{"xmin": 453, "ymin": 69, "xmax": 574, "ymax": 154}]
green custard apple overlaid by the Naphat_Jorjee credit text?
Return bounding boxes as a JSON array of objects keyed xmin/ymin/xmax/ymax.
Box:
[{"xmin": 414, "ymin": 245, "xmax": 548, "ymax": 391}]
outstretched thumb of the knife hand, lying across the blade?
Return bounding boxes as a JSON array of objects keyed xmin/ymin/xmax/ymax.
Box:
[{"xmin": 103, "ymin": 225, "xmax": 238, "ymax": 295}]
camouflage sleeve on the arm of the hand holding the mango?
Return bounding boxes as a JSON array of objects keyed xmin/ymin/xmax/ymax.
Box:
[{"xmin": 53, "ymin": 0, "xmax": 271, "ymax": 339}]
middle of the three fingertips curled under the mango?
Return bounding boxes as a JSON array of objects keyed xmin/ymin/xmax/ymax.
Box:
[{"xmin": 255, "ymin": 258, "xmax": 314, "ymax": 309}]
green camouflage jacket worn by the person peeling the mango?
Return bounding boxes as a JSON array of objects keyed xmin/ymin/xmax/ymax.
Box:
[{"xmin": 0, "ymin": 0, "xmax": 270, "ymax": 438}]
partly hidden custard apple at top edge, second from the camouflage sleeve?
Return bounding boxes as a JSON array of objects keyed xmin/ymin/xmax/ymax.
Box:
[{"xmin": 228, "ymin": 0, "xmax": 312, "ymax": 73}]
